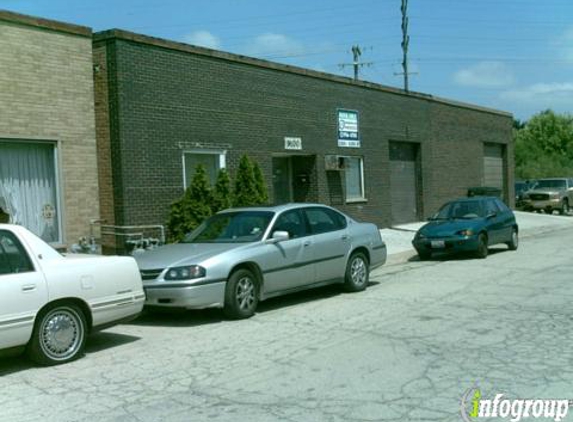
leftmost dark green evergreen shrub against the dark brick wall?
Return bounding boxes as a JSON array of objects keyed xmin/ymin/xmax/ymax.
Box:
[{"xmin": 167, "ymin": 164, "xmax": 213, "ymax": 242}]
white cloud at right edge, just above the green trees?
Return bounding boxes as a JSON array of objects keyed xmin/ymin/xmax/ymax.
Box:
[{"xmin": 500, "ymin": 82, "xmax": 573, "ymax": 105}]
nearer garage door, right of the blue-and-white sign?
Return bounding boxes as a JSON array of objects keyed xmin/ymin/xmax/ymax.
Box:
[{"xmin": 390, "ymin": 142, "xmax": 418, "ymax": 224}]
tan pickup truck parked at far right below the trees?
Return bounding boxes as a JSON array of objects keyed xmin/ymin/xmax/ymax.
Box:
[{"xmin": 523, "ymin": 177, "xmax": 573, "ymax": 215}]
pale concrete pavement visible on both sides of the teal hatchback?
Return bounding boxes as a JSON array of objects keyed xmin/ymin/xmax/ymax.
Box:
[{"xmin": 380, "ymin": 211, "xmax": 573, "ymax": 265}]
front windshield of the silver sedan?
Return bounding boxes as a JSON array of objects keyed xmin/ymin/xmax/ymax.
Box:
[{"xmin": 181, "ymin": 211, "xmax": 274, "ymax": 243}]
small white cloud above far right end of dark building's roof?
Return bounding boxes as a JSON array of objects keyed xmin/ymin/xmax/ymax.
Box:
[{"xmin": 454, "ymin": 61, "xmax": 515, "ymax": 88}]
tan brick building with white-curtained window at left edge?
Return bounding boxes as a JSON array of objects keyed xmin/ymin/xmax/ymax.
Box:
[{"xmin": 0, "ymin": 11, "xmax": 99, "ymax": 244}]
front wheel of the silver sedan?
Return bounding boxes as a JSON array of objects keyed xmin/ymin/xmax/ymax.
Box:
[{"xmin": 223, "ymin": 268, "xmax": 259, "ymax": 319}]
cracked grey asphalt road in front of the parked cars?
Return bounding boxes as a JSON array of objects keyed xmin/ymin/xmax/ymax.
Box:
[{"xmin": 0, "ymin": 229, "xmax": 573, "ymax": 422}]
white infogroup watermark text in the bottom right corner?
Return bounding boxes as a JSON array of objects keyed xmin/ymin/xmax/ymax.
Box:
[{"xmin": 460, "ymin": 387, "xmax": 572, "ymax": 422}]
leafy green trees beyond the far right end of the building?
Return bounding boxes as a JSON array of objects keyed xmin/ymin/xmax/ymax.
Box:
[{"xmin": 514, "ymin": 110, "xmax": 573, "ymax": 179}]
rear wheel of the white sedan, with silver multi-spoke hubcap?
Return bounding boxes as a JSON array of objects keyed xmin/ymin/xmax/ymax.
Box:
[{"xmin": 26, "ymin": 304, "xmax": 87, "ymax": 366}]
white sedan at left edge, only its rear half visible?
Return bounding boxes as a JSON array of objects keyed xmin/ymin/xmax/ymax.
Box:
[{"xmin": 0, "ymin": 224, "xmax": 145, "ymax": 365}]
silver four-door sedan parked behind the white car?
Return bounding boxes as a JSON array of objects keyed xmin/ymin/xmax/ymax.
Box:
[{"xmin": 136, "ymin": 204, "xmax": 386, "ymax": 318}]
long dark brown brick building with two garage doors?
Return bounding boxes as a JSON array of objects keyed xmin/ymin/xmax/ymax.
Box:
[{"xmin": 94, "ymin": 30, "xmax": 513, "ymax": 244}]
